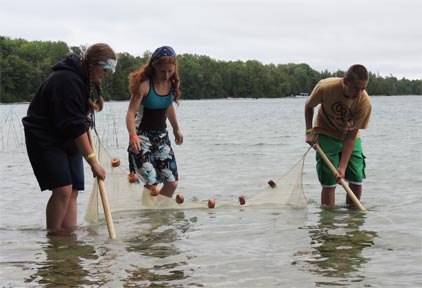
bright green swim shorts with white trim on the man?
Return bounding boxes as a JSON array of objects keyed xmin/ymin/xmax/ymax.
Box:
[{"xmin": 316, "ymin": 134, "xmax": 366, "ymax": 187}]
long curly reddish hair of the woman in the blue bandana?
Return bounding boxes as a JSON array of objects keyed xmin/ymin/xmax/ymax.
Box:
[{"xmin": 129, "ymin": 56, "xmax": 182, "ymax": 104}]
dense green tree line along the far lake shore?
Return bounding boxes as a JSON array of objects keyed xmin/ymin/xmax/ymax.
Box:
[{"xmin": 0, "ymin": 36, "xmax": 422, "ymax": 103}]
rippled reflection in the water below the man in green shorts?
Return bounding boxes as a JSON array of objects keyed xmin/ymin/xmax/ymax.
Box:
[{"xmin": 296, "ymin": 209, "xmax": 377, "ymax": 285}]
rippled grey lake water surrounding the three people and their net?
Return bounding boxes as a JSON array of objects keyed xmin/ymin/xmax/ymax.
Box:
[{"xmin": 0, "ymin": 96, "xmax": 422, "ymax": 288}]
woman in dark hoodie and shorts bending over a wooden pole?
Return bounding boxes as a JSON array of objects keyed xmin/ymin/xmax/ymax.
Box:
[{"xmin": 22, "ymin": 43, "xmax": 117, "ymax": 235}]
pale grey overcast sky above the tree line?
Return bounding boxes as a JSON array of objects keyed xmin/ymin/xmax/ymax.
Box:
[{"xmin": 0, "ymin": 0, "xmax": 422, "ymax": 79}]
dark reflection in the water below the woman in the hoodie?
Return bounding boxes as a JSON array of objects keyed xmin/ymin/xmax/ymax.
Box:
[{"xmin": 25, "ymin": 234, "xmax": 98, "ymax": 287}]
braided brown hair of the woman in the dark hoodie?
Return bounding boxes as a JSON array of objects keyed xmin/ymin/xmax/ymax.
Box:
[{"xmin": 82, "ymin": 43, "xmax": 116, "ymax": 111}]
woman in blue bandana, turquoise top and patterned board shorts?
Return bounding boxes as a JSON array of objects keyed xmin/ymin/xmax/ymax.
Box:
[{"xmin": 126, "ymin": 46, "xmax": 183, "ymax": 197}]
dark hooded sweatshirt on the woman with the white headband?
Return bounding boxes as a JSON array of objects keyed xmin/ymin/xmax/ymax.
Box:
[{"xmin": 22, "ymin": 55, "xmax": 90, "ymax": 146}]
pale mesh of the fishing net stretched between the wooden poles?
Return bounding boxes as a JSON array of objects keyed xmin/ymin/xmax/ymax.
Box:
[{"xmin": 85, "ymin": 138, "xmax": 309, "ymax": 223}]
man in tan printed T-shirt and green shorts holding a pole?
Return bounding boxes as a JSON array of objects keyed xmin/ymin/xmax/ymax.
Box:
[{"xmin": 305, "ymin": 64, "xmax": 371, "ymax": 206}]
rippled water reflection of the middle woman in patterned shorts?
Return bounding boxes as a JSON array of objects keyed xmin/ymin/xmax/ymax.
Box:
[{"xmin": 125, "ymin": 210, "xmax": 194, "ymax": 287}]
